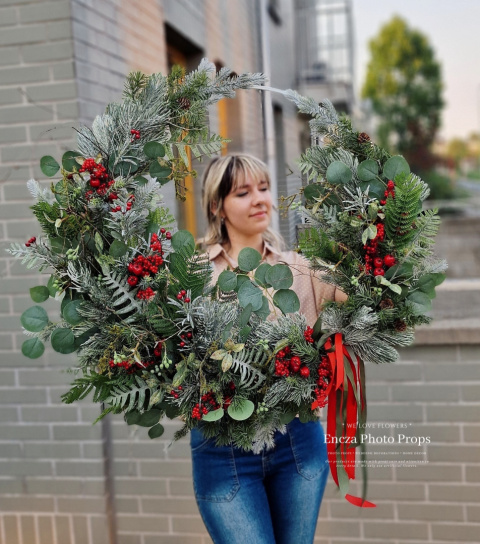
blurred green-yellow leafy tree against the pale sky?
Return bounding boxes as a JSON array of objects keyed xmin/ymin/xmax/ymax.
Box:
[{"xmin": 362, "ymin": 16, "xmax": 444, "ymax": 170}]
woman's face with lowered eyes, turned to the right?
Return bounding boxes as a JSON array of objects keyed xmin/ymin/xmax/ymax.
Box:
[{"xmin": 221, "ymin": 174, "xmax": 272, "ymax": 238}]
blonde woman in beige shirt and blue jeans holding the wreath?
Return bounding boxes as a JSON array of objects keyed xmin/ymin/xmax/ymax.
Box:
[{"xmin": 191, "ymin": 154, "xmax": 345, "ymax": 544}]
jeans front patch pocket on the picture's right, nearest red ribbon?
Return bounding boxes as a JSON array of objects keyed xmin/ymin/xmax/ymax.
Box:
[{"xmin": 287, "ymin": 418, "xmax": 328, "ymax": 480}]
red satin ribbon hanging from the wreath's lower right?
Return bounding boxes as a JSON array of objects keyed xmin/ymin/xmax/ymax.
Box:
[{"xmin": 322, "ymin": 333, "xmax": 376, "ymax": 508}]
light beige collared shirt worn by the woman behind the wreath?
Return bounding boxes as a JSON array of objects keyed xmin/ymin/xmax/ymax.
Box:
[{"xmin": 206, "ymin": 242, "xmax": 344, "ymax": 327}]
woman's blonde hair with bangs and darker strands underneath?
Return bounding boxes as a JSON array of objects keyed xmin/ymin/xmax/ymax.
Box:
[{"xmin": 202, "ymin": 153, "xmax": 285, "ymax": 251}]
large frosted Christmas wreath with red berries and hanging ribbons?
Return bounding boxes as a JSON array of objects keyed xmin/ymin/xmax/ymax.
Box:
[{"xmin": 10, "ymin": 60, "xmax": 446, "ymax": 506}]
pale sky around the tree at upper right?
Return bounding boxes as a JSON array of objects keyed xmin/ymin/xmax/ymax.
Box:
[{"xmin": 352, "ymin": 0, "xmax": 480, "ymax": 139}]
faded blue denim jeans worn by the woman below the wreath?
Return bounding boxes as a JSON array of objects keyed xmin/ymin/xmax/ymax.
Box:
[{"xmin": 190, "ymin": 418, "xmax": 329, "ymax": 544}]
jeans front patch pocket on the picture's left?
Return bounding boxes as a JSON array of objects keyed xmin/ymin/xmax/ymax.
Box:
[{"xmin": 192, "ymin": 433, "xmax": 240, "ymax": 502}]
